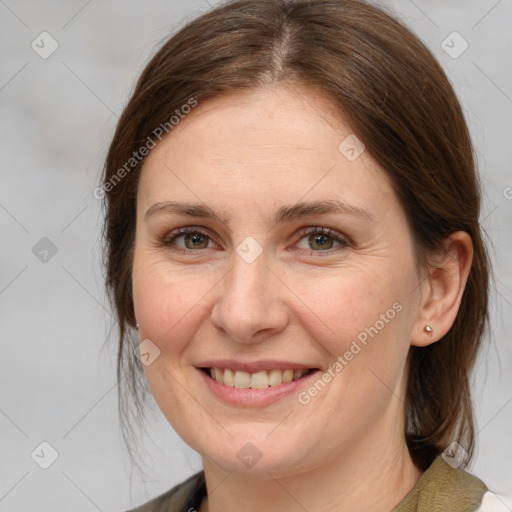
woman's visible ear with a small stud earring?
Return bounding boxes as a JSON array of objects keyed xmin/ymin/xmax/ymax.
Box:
[{"xmin": 411, "ymin": 231, "xmax": 473, "ymax": 347}]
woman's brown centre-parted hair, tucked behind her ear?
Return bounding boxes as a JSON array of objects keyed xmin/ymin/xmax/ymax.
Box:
[{"xmin": 102, "ymin": 0, "xmax": 489, "ymax": 469}]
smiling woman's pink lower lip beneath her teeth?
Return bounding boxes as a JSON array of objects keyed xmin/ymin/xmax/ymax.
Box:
[{"xmin": 197, "ymin": 369, "xmax": 320, "ymax": 407}]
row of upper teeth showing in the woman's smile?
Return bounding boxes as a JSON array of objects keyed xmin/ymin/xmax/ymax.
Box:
[{"xmin": 209, "ymin": 368, "xmax": 309, "ymax": 389}]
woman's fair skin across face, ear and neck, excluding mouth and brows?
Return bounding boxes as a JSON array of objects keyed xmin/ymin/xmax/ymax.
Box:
[{"xmin": 133, "ymin": 86, "xmax": 472, "ymax": 512}]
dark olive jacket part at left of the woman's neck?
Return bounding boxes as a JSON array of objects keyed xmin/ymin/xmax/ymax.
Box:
[{"xmin": 127, "ymin": 471, "xmax": 206, "ymax": 512}]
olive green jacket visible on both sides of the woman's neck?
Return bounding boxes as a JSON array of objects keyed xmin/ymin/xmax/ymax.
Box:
[{"xmin": 129, "ymin": 456, "xmax": 487, "ymax": 512}]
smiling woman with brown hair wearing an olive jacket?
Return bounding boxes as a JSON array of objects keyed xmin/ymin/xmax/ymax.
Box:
[{"xmin": 103, "ymin": 0, "xmax": 498, "ymax": 512}]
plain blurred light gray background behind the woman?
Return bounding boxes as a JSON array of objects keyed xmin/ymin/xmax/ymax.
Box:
[{"xmin": 0, "ymin": 0, "xmax": 512, "ymax": 512}]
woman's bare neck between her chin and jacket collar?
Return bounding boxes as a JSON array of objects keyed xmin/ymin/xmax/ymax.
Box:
[{"xmin": 200, "ymin": 424, "xmax": 422, "ymax": 512}]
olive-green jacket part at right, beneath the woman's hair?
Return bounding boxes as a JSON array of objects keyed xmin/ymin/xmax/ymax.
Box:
[{"xmin": 393, "ymin": 456, "xmax": 487, "ymax": 512}]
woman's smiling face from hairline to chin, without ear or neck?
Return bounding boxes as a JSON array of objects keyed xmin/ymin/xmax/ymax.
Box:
[{"xmin": 133, "ymin": 87, "xmax": 419, "ymax": 478}]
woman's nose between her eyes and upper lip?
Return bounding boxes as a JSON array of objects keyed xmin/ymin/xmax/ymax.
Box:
[{"xmin": 211, "ymin": 251, "xmax": 290, "ymax": 344}]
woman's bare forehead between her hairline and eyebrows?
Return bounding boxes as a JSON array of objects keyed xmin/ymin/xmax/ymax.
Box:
[{"xmin": 138, "ymin": 87, "xmax": 396, "ymax": 224}]
